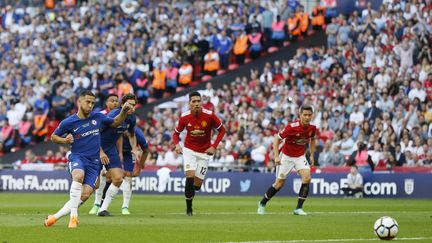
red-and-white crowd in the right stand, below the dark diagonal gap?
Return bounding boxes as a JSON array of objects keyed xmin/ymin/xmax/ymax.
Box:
[{"xmin": 139, "ymin": 1, "xmax": 432, "ymax": 171}]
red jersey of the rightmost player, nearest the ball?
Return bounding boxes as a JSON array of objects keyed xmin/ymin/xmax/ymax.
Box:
[{"xmin": 278, "ymin": 121, "xmax": 316, "ymax": 157}]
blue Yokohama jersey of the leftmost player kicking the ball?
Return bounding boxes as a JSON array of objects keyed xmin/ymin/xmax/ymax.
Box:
[{"xmin": 54, "ymin": 112, "xmax": 114, "ymax": 161}]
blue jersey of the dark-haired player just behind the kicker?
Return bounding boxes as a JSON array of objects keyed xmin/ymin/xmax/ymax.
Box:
[{"xmin": 101, "ymin": 108, "xmax": 136, "ymax": 151}]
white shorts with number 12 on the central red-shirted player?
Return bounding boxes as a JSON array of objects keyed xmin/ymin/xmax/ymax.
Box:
[{"xmin": 183, "ymin": 147, "xmax": 211, "ymax": 179}]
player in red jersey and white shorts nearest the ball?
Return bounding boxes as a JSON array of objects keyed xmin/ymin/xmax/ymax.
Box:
[{"xmin": 257, "ymin": 106, "xmax": 317, "ymax": 215}]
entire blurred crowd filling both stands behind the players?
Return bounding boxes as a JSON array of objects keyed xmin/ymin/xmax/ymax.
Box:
[{"xmin": 0, "ymin": 0, "xmax": 432, "ymax": 171}]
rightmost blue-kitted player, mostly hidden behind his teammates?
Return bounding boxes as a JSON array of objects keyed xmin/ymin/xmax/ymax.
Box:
[{"xmin": 119, "ymin": 127, "xmax": 149, "ymax": 215}]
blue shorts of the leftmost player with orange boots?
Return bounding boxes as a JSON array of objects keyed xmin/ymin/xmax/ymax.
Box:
[{"xmin": 68, "ymin": 154, "xmax": 102, "ymax": 190}]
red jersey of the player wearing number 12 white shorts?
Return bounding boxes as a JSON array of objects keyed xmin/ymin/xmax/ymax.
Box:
[{"xmin": 175, "ymin": 109, "xmax": 222, "ymax": 153}]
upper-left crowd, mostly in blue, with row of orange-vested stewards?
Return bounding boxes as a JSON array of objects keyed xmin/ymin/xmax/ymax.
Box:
[{"xmin": 0, "ymin": 0, "xmax": 323, "ymax": 156}]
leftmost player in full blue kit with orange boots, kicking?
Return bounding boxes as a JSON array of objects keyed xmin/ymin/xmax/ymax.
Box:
[{"xmin": 44, "ymin": 90, "xmax": 133, "ymax": 228}]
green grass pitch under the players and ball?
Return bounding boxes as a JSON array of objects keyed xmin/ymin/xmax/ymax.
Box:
[{"xmin": 0, "ymin": 193, "xmax": 432, "ymax": 243}]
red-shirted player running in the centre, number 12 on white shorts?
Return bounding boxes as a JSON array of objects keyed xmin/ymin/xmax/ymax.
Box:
[{"xmin": 173, "ymin": 92, "xmax": 225, "ymax": 216}]
